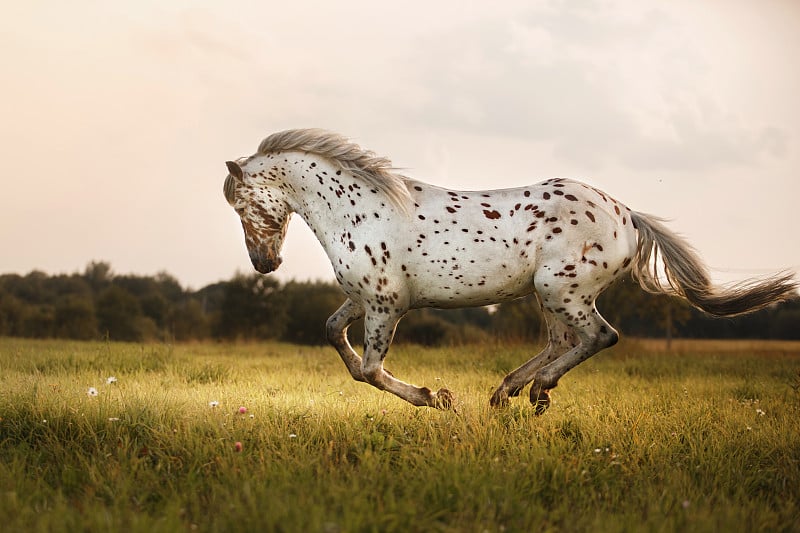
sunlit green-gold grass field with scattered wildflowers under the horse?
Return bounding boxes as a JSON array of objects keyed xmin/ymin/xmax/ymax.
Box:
[{"xmin": 0, "ymin": 339, "xmax": 800, "ymax": 532}]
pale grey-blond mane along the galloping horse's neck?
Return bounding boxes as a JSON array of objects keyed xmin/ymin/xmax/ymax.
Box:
[{"xmin": 258, "ymin": 128, "xmax": 411, "ymax": 212}]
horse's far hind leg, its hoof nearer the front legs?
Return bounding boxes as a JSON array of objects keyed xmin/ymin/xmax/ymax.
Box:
[{"xmin": 489, "ymin": 311, "xmax": 578, "ymax": 407}]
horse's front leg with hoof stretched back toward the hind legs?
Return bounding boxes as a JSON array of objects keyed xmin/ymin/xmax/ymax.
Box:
[{"xmin": 361, "ymin": 313, "xmax": 453, "ymax": 409}]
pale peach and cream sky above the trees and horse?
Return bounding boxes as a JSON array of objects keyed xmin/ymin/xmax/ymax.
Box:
[{"xmin": 0, "ymin": 0, "xmax": 800, "ymax": 289}]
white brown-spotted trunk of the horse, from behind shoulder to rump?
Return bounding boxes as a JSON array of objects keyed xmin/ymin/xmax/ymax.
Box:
[{"xmin": 399, "ymin": 179, "xmax": 635, "ymax": 307}]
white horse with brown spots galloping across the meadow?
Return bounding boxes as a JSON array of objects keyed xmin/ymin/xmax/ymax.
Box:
[{"xmin": 223, "ymin": 129, "xmax": 798, "ymax": 414}]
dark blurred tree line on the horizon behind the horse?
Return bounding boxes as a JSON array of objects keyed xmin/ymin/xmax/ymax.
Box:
[{"xmin": 0, "ymin": 262, "xmax": 800, "ymax": 346}]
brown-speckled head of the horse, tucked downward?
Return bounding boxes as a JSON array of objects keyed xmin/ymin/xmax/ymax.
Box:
[{"xmin": 223, "ymin": 161, "xmax": 291, "ymax": 274}]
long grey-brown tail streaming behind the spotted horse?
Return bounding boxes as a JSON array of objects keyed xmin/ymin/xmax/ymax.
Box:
[{"xmin": 631, "ymin": 212, "xmax": 798, "ymax": 317}]
